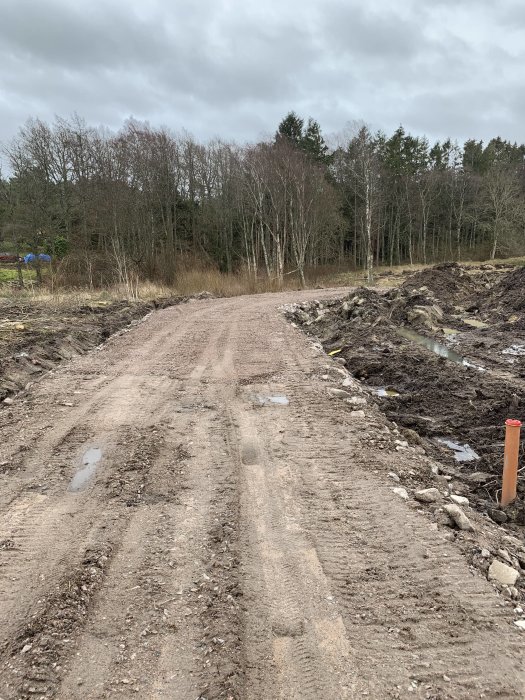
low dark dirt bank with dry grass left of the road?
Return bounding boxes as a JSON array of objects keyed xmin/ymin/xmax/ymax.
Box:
[{"xmin": 0, "ymin": 297, "xmax": 188, "ymax": 404}]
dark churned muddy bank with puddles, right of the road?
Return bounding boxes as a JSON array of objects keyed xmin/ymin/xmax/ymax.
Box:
[{"xmin": 286, "ymin": 264, "xmax": 525, "ymax": 536}]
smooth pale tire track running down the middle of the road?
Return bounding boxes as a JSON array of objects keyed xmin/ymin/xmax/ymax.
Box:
[{"xmin": 232, "ymin": 396, "xmax": 356, "ymax": 698}]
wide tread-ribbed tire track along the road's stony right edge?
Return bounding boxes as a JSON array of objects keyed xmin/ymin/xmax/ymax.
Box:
[{"xmin": 276, "ymin": 378, "xmax": 521, "ymax": 698}]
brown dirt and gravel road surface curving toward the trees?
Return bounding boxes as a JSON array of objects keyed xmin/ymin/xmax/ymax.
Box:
[{"xmin": 0, "ymin": 292, "xmax": 525, "ymax": 700}]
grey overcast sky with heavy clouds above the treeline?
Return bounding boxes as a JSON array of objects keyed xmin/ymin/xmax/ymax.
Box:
[{"xmin": 0, "ymin": 0, "xmax": 525, "ymax": 157}]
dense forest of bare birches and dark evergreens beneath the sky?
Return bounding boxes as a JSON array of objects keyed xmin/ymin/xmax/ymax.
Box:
[{"xmin": 0, "ymin": 112, "xmax": 525, "ymax": 284}]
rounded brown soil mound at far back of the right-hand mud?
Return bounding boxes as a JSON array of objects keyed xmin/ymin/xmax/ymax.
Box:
[{"xmin": 401, "ymin": 263, "xmax": 478, "ymax": 304}]
